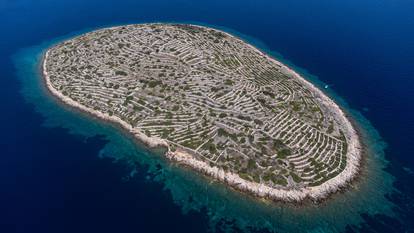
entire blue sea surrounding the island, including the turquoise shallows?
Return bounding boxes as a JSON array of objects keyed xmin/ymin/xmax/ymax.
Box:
[{"xmin": 0, "ymin": 0, "xmax": 414, "ymax": 233}]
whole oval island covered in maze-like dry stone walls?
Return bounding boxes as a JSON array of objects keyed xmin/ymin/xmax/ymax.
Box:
[{"xmin": 42, "ymin": 23, "xmax": 362, "ymax": 202}]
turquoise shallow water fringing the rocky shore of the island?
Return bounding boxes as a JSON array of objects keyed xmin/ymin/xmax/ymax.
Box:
[{"xmin": 14, "ymin": 25, "xmax": 395, "ymax": 232}]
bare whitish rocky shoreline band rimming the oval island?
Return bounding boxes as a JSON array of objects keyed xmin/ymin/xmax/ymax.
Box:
[{"xmin": 42, "ymin": 25, "xmax": 361, "ymax": 202}]
